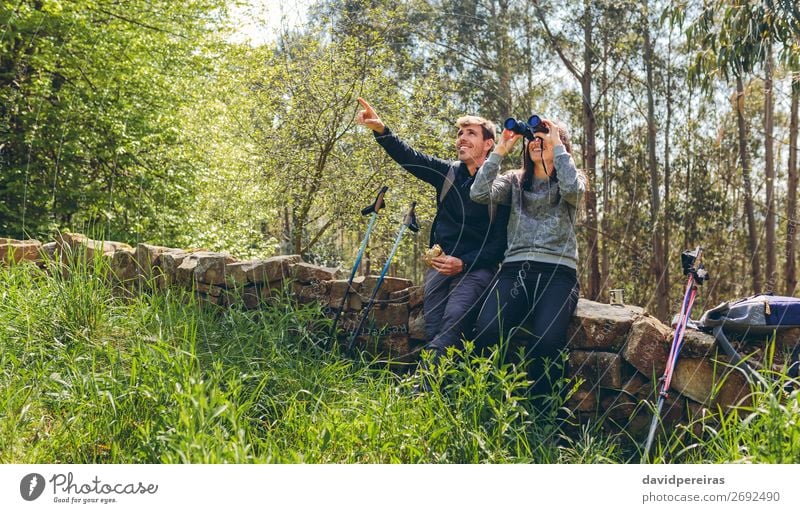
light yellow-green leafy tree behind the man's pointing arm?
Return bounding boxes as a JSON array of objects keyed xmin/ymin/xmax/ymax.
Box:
[{"xmin": 179, "ymin": 22, "xmax": 456, "ymax": 265}]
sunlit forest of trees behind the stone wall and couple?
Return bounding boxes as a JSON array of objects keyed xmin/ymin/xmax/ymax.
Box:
[{"xmin": 0, "ymin": 0, "xmax": 800, "ymax": 319}]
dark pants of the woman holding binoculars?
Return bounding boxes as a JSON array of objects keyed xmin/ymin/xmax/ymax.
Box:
[{"xmin": 475, "ymin": 261, "xmax": 580, "ymax": 394}]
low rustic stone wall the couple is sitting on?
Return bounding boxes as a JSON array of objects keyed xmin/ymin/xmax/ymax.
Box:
[{"xmin": 0, "ymin": 234, "xmax": 764, "ymax": 433}]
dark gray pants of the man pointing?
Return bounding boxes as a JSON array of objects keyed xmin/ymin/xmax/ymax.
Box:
[{"xmin": 424, "ymin": 269, "xmax": 495, "ymax": 354}]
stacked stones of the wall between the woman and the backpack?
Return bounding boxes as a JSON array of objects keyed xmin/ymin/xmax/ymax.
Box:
[{"xmin": 567, "ymin": 299, "xmax": 749, "ymax": 434}]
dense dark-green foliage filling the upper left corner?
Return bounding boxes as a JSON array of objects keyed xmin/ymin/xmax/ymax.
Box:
[{"xmin": 0, "ymin": 0, "xmax": 231, "ymax": 239}]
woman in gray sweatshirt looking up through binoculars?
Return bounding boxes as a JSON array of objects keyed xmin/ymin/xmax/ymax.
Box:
[{"xmin": 470, "ymin": 119, "xmax": 587, "ymax": 395}]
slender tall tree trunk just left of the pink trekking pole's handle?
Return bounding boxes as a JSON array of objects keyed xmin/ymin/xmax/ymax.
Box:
[{"xmin": 642, "ymin": 7, "xmax": 668, "ymax": 321}]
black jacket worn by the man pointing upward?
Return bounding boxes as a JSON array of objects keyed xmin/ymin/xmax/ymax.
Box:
[{"xmin": 373, "ymin": 127, "xmax": 509, "ymax": 270}]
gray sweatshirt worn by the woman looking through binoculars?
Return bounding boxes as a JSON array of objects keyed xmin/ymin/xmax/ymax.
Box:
[{"xmin": 469, "ymin": 145, "xmax": 586, "ymax": 269}]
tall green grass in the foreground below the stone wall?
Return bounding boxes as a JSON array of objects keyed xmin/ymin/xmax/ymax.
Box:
[{"xmin": 0, "ymin": 253, "xmax": 800, "ymax": 463}]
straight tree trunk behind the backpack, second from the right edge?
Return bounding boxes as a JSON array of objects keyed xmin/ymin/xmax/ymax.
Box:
[{"xmin": 764, "ymin": 44, "xmax": 778, "ymax": 292}]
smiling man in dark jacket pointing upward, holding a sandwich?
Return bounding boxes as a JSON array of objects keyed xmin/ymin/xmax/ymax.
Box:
[{"xmin": 356, "ymin": 98, "xmax": 509, "ymax": 361}]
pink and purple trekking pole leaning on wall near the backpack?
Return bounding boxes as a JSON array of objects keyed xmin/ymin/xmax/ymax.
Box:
[{"xmin": 642, "ymin": 246, "xmax": 709, "ymax": 463}]
